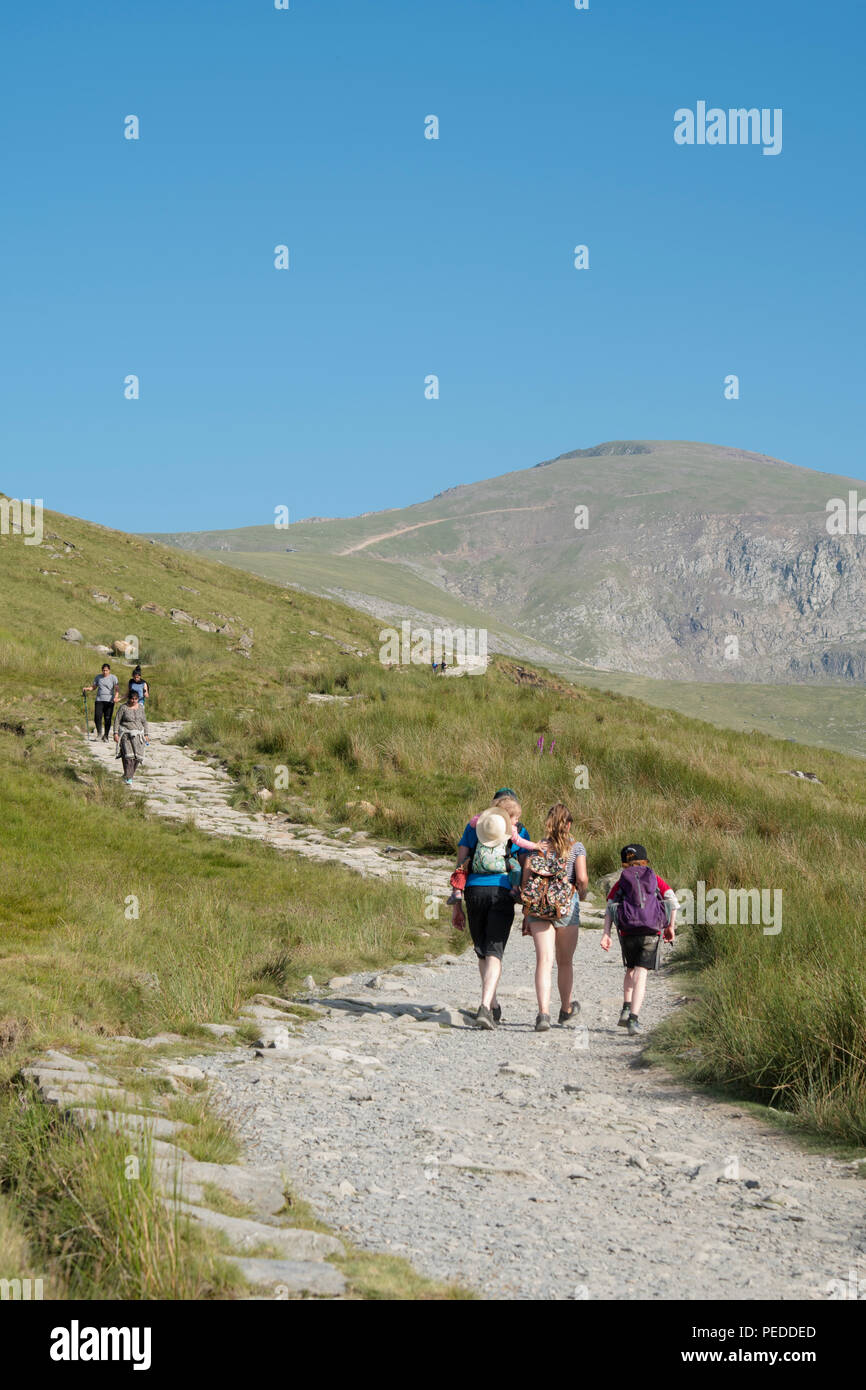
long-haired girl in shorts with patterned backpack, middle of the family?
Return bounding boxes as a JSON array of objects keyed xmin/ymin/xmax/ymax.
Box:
[{"xmin": 521, "ymin": 801, "xmax": 589, "ymax": 1033}]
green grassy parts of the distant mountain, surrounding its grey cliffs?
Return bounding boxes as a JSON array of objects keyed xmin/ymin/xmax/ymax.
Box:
[{"xmin": 145, "ymin": 441, "xmax": 866, "ymax": 756}]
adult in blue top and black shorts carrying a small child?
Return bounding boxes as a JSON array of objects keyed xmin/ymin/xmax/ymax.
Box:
[{"xmin": 452, "ymin": 787, "xmax": 528, "ymax": 1030}]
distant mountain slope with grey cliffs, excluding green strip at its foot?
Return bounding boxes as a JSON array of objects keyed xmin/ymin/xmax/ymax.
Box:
[{"xmin": 148, "ymin": 441, "xmax": 866, "ymax": 682}]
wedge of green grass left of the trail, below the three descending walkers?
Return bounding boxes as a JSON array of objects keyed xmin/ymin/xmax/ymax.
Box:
[{"xmin": 0, "ymin": 733, "xmax": 461, "ymax": 1054}]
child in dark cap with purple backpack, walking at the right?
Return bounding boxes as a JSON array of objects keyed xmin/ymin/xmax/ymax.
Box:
[{"xmin": 602, "ymin": 845, "xmax": 678, "ymax": 1036}]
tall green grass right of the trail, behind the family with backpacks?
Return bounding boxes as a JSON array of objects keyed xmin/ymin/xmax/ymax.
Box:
[{"xmin": 180, "ymin": 662, "xmax": 866, "ymax": 1143}]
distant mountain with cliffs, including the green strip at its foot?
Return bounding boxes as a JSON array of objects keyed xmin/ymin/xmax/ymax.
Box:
[{"xmin": 145, "ymin": 441, "xmax": 866, "ymax": 755}]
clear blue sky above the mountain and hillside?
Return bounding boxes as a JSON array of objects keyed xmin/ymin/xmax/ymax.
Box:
[{"xmin": 0, "ymin": 0, "xmax": 866, "ymax": 530}]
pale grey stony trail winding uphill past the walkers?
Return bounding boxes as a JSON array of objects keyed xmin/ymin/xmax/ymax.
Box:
[{"xmin": 76, "ymin": 724, "xmax": 866, "ymax": 1300}]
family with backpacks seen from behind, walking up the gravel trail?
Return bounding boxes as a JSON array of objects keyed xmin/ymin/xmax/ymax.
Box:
[{"xmin": 449, "ymin": 787, "xmax": 677, "ymax": 1034}]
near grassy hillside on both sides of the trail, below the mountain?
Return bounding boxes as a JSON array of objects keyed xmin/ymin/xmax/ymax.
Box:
[{"xmin": 0, "ymin": 503, "xmax": 866, "ymax": 1291}]
